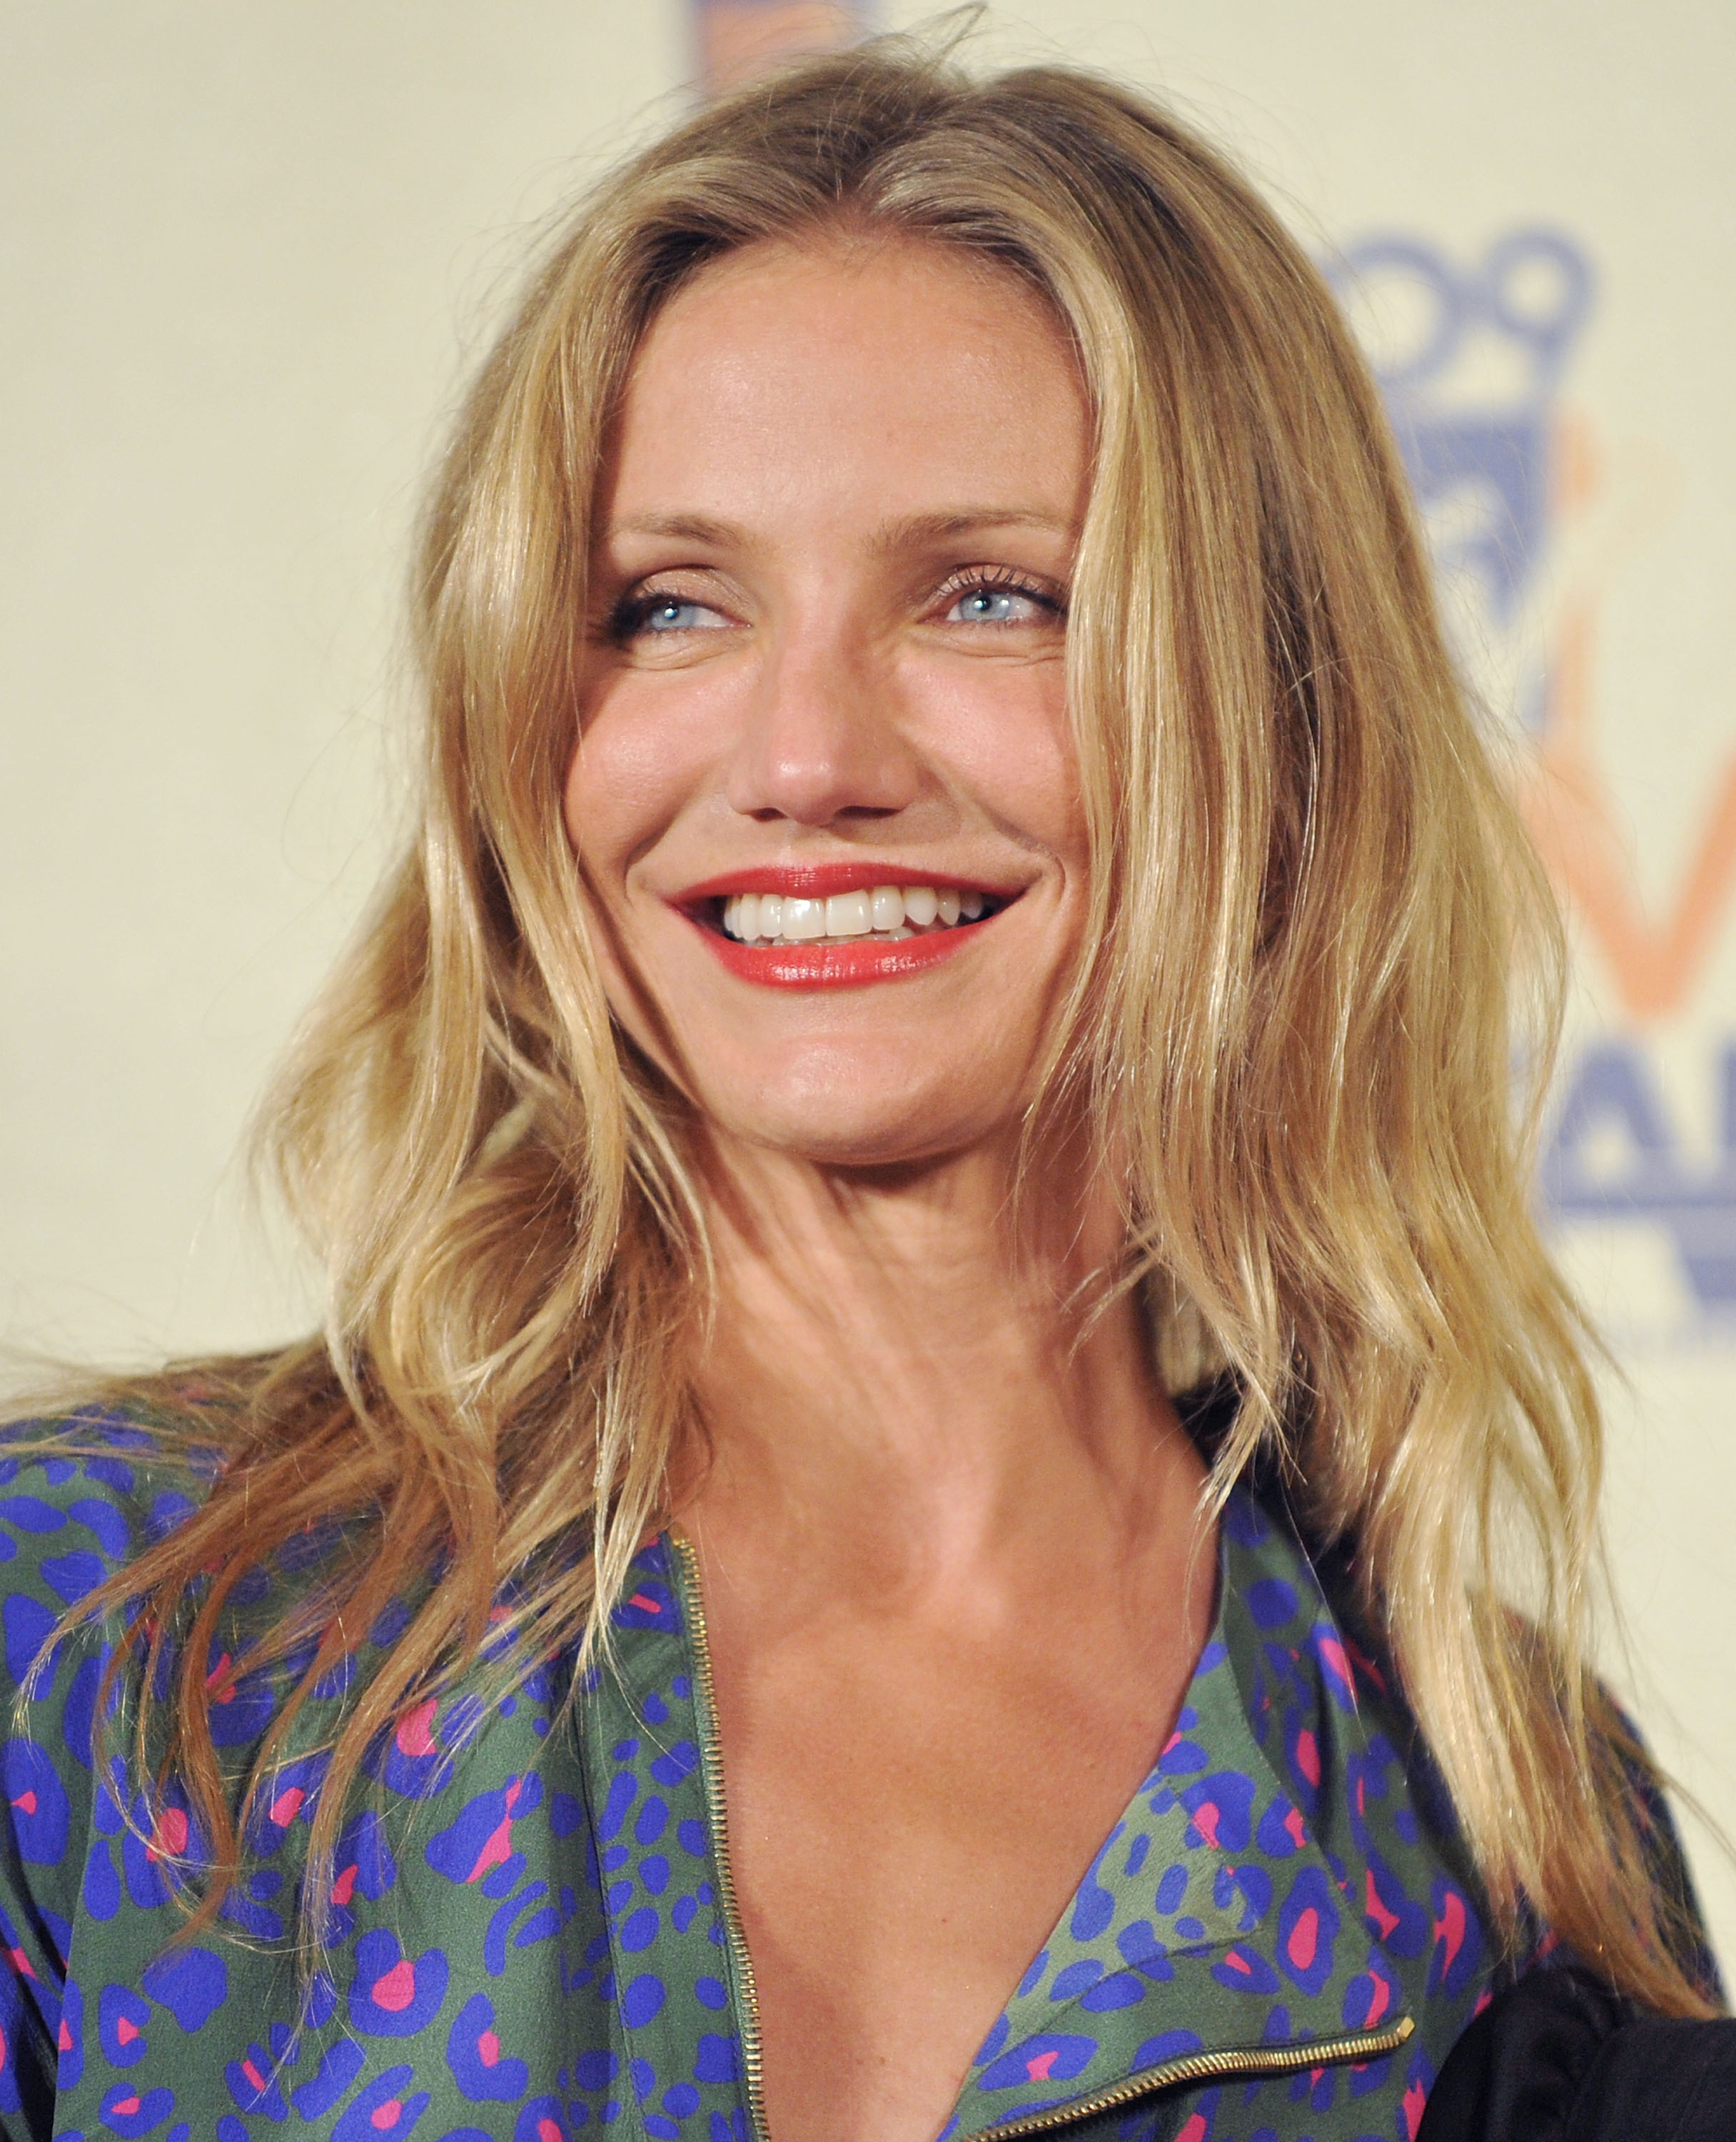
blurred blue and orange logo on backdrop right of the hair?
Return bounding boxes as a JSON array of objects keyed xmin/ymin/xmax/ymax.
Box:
[{"xmin": 1327, "ymin": 229, "xmax": 1736, "ymax": 1319}]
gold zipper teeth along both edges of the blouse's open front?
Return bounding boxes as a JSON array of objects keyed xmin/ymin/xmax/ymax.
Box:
[{"xmin": 670, "ymin": 1525, "xmax": 1417, "ymax": 2142}]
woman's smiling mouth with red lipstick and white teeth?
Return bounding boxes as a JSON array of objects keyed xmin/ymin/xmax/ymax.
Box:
[{"xmin": 677, "ymin": 863, "xmax": 1019, "ymax": 987}]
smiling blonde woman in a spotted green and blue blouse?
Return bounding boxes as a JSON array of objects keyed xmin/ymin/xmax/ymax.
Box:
[{"xmin": 0, "ymin": 33, "xmax": 1715, "ymax": 2142}]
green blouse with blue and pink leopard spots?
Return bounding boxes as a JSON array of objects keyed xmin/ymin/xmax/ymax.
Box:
[{"xmin": 0, "ymin": 1420, "xmax": 1558, "ymax": 2142}]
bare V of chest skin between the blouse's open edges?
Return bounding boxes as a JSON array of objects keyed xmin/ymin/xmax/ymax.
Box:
[{"xmin": 717, "ymin": 1615, "xmax": 1194, "ymax": 2142}]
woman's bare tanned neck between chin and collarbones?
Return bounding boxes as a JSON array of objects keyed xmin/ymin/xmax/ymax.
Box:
[{"xmin": 677, "ymin": 1148, "xmax": 1201, "ymax": 1579}]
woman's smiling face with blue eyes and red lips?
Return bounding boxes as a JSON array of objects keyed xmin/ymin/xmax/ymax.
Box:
[{"xmin": 565, "ymin": 240, "xmax": 1089, "ymax": 1165}]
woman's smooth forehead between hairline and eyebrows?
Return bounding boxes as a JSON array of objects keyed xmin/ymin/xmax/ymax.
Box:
[{"xmin": 606, "ymin": 236, "xmax": 1089, "ymax": 536}]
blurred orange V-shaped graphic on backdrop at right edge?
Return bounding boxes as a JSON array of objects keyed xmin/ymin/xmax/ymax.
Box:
[{"xmin": 1522, "ymin": 608, "xmax": 1736, "ymax": 1020}]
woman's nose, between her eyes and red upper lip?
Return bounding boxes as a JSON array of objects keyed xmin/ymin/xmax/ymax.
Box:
[{"xmin": 726, "ymin": 619, "xmax": 920, "ymax": 827}]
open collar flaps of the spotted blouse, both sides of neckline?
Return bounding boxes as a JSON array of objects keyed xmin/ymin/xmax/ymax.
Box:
[{"xmin": 582, "ymin": 1493, "xmax": 1490, "ymax": 2142}]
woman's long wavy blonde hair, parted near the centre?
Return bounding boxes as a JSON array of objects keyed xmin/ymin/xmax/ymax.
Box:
[{"xmin": 20, "ymin": 41, "xmax": 1708, "ymax": 2013}]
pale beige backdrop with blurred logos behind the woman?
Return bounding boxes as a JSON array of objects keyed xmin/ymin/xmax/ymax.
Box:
[{"xmin": 0, "ymin": 0, "xmax": 1736, "ymax": 1960}]
